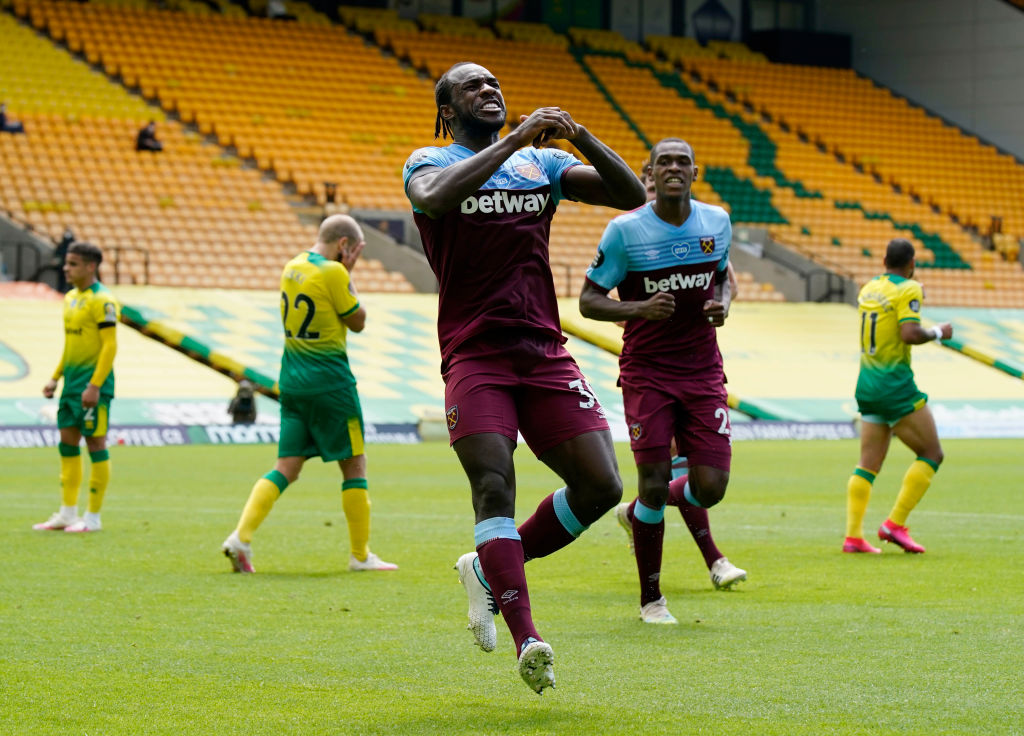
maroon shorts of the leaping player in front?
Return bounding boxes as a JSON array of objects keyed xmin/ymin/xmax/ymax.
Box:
[{"xmin": 442, "ymin": 331, "xmax": 608, "ymax": 456}]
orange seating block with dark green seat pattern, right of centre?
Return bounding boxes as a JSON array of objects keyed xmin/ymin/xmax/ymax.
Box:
[{"xmin": 569, "ymin": 44, "xmax": 1024, "ymax": 306}]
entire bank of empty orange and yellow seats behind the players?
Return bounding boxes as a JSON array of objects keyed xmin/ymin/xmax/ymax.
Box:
[{"xmin": 8, "ymin": 0, "xmax": 1024, "ymax": 306}]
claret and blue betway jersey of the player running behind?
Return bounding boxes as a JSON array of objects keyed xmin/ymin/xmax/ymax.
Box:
[{"xmin": 587, "ymin": 200, "xmax": 732, "ymax": 369}]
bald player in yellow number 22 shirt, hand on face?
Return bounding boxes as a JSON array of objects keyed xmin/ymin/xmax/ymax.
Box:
[{"xmin": 221, "ymin": 215, "xmax": 398, "ymax": 572}]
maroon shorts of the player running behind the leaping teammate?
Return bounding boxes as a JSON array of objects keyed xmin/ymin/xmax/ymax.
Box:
[{"xmin": 623, "ymin": 377, "xmax": 732, "ymax": 470}]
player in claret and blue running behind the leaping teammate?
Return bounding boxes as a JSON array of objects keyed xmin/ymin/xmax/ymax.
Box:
[{"xmin": 580, "ymin": 138, "xmax": 745, "ymax": 623}]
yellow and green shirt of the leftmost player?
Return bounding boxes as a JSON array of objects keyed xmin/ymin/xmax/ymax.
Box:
[{"xmin": 61, "ymin": 282, "xmax": 121, "ymax": 396}]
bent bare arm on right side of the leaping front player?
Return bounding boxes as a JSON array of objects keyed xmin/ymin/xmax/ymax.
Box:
[{"xmin": 565, "ymin": 126, "xmax": 647, "ymax": 210}]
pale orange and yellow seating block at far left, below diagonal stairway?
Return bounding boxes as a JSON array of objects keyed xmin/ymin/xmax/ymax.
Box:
[{"xmin": 0, "ymin": 0, "xmax": 413, "ymax": 291}]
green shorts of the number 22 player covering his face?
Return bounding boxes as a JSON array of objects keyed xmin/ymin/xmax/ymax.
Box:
[{"xmin": 278, "ymin": 386, "xmax": 365, "ymax": 463}]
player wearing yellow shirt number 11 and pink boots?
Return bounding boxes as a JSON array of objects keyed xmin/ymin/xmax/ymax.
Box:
[{"xmin": 843, "ymin": 237, "xmax": 953, "ymax": 554}]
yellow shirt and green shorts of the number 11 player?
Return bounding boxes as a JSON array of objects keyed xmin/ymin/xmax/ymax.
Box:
[{"xmin": 856, "ymin": 273, "xmax": 927, "ymax": 416}]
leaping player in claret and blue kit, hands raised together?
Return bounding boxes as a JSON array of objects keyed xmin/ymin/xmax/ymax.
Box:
[{"xmin": 404, "ymin": 62, "xmax": 644, "ymax": 693}]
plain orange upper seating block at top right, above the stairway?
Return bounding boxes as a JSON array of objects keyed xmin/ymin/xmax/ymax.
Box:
[{"xmin": 683, "ymin": 58, "xmax": 1024, "ymax": 244}]
